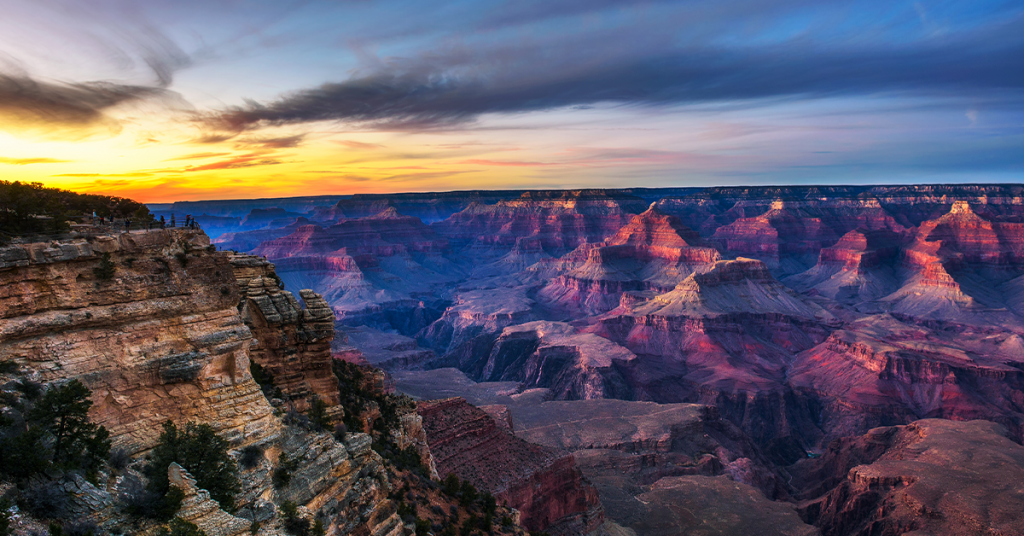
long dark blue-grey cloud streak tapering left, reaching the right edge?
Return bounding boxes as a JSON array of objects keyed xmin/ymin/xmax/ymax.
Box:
[{"xmin": 203, "ymin": 10, "xmax": 1024, "ymax": 132}]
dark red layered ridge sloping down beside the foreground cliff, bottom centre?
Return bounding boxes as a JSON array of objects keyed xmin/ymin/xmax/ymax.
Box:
[{"xmin": 417, "ymin": 399, "xmax": 604, "ymax": 534}]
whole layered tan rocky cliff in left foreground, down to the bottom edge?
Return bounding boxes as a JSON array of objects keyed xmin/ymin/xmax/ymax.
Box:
[{"xmin": 0, "ymin": 230, "xmax": 544, "ymax": 536}]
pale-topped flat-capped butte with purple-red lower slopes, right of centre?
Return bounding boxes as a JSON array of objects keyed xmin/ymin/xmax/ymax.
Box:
[{"xmin": 589, "ymin": 259, "xmax": 838, "ymax": 459}]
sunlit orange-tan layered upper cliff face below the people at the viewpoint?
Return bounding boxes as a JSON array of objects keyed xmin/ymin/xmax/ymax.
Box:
[{"xmin": 0, "ymin": 230, "xmax": 280, "ymax": 451}]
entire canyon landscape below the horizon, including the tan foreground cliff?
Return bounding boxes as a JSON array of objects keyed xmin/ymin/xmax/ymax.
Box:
[{"xmin": 6, "ymin": 184, "xmax": 1024, "ymax": 536}]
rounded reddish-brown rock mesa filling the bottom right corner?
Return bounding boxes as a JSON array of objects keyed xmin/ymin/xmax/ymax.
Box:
[{"xmin": 794, "ymin": 419, "xmax": 1024, "ymax": 536}]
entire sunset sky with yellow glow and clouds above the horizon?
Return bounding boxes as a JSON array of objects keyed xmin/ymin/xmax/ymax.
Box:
[{"xmin": 0, "ymin": 0, "xmax": 1024, "ymax": 203}]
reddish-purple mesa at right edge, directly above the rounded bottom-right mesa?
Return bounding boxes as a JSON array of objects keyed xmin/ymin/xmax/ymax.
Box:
[{"xmin": 788, "ymin": 315, "xmax": 1024, "ymax": 443}]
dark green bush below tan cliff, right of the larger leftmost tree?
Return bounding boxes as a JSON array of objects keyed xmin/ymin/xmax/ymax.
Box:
[{"xmin": 143, "ymin": 421, "xmax": 241, "ymax": 511}]
